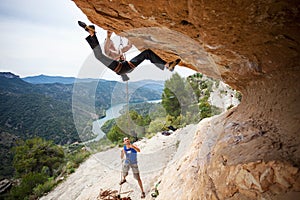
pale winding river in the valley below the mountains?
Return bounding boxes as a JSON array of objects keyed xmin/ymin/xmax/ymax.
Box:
[{"xmin": 91, "ymin": 99, "xmax": 161, "ymax": 141}]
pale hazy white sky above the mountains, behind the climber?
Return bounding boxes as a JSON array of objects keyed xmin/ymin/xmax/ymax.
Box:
[{"xmin": 0, "ymin": 0, "xmax": 193, "ymax": 80}]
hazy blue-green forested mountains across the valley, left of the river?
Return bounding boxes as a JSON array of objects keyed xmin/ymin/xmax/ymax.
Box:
[{"xmin": 0, "ymin": 72, "xmax": 163, "ymax": 141}]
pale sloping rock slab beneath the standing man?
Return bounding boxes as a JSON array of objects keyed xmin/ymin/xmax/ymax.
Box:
[{"xmin": 41, "ymin": 125, "xmax": 196, "ymax": 200}]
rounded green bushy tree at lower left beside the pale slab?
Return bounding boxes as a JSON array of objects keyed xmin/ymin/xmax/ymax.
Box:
[{"xmin": 13, "ymin": 138, "xmax": 64, "ymax": 176}]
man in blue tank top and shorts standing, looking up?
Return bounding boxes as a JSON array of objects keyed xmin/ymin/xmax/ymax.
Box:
[{"xmin": 120, "ymin": 137, "xmax": 145, "ymax": 198}]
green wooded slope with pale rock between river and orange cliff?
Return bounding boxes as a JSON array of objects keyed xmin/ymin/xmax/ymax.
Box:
[{"xmin": 98, "ymin": 73, "xmax": 241, "ymax": 149}]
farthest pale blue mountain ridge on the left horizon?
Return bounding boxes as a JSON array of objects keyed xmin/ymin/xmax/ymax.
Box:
[{"xmin": 22, "ymin": 75, "xmax": 98, "ymax": 84}]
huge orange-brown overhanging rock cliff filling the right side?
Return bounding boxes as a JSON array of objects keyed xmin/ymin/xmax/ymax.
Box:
[{"xmin": 74, "ymin": 0, "xmax": 300, "ymax": 199}]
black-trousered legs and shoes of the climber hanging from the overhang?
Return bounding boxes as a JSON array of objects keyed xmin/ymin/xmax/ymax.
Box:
[{"xmin": 78, "ymin": 21, "xmax": 181, "ymax": 81}]
